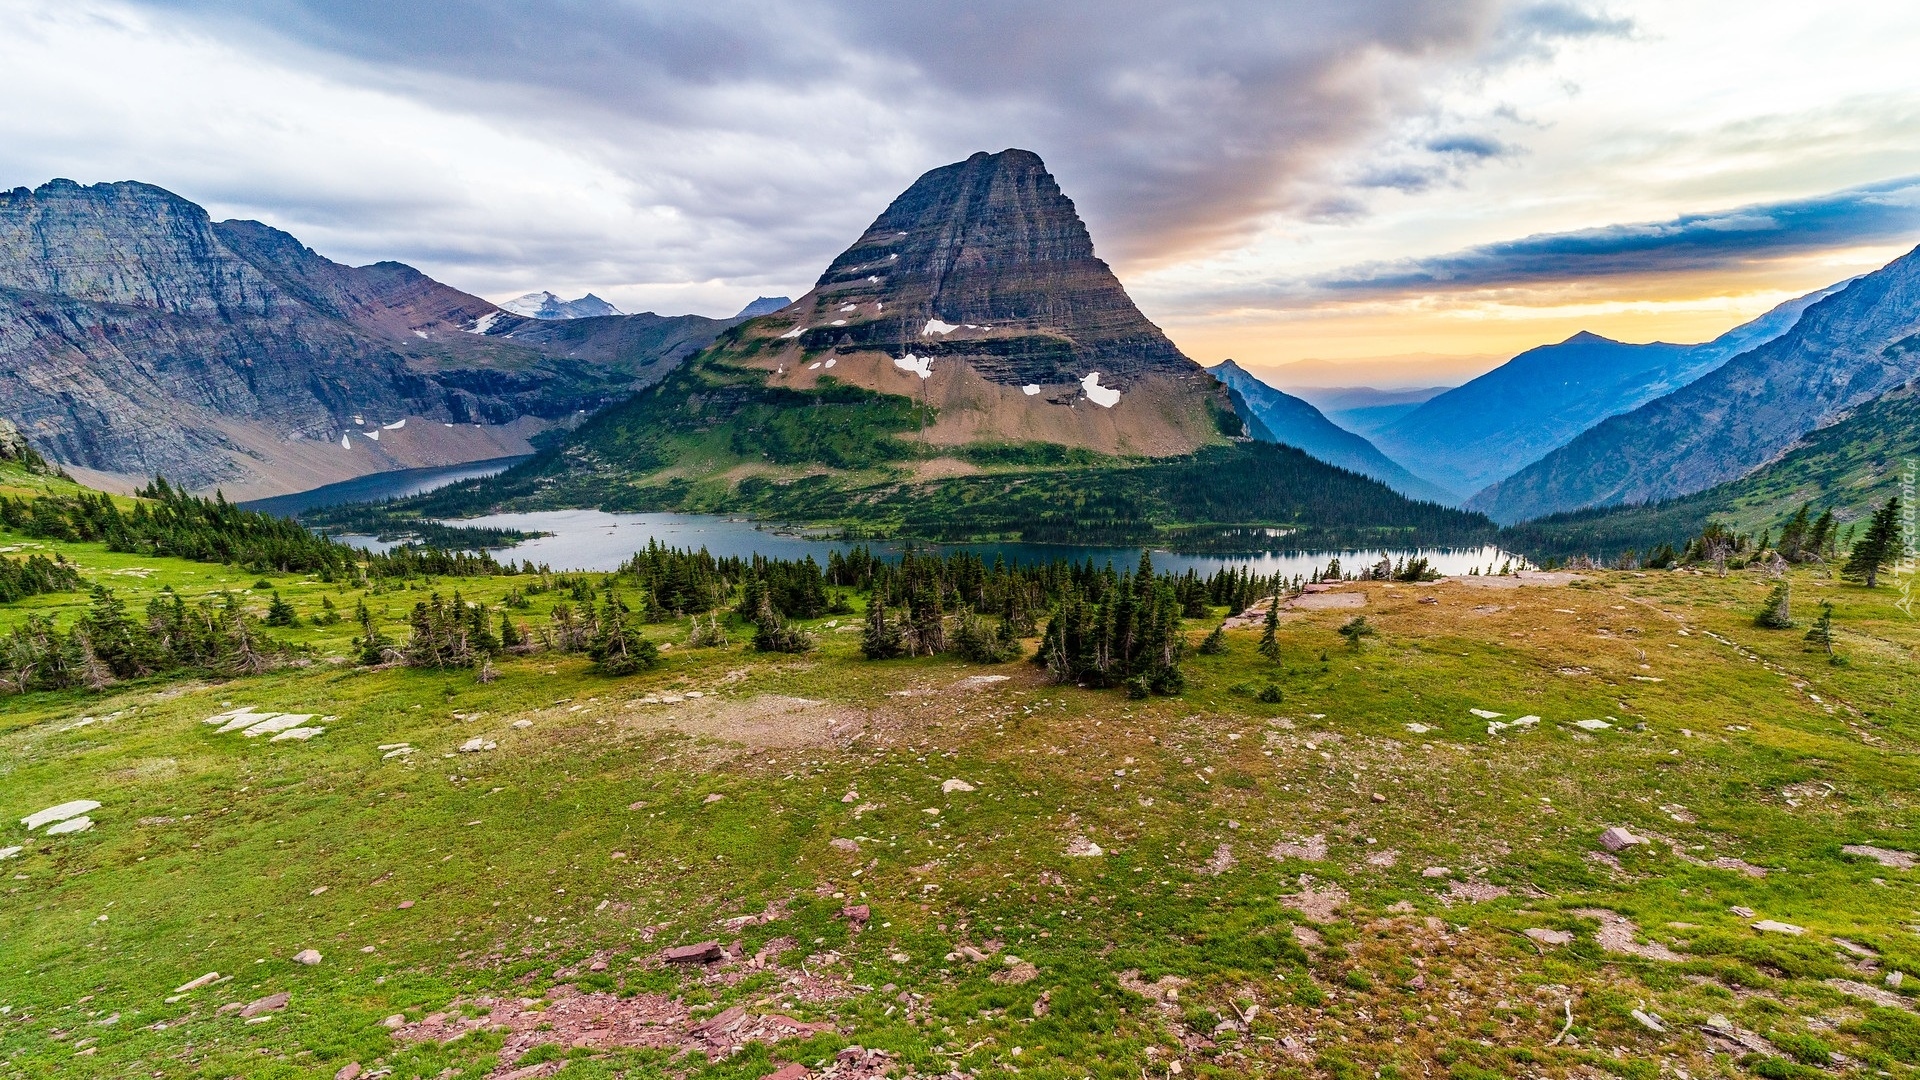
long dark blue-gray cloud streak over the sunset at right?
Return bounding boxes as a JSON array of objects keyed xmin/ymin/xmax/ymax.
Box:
[{"xmin": 1313, "ymin": 177, "xmax": 1920, "ymax": 300}]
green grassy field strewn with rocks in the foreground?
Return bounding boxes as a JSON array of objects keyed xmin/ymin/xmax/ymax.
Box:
[{"xmin": 0, "ymin": 518, "xmax": 1920, "ymax": 1080}]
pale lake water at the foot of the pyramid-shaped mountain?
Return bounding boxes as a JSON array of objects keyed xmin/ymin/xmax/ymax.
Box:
[{"xmin": 340, "ymin": 509, "xmax": 1519, "ymax": 577}]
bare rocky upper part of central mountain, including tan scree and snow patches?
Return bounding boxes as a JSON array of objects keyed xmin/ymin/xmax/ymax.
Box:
[{"xmin": 712, "ymin": 150, "xmax": 1233, "ymax": 455}]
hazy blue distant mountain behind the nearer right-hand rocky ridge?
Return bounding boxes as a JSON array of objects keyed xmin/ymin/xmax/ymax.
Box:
[{"xmin": 1373, "ymin": 286, "xmax": 1839, "ymax": 500}]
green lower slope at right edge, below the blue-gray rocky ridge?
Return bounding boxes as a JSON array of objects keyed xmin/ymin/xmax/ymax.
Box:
[{"xmin": 1501, "ymin": 382, "xmax": 1920, "ymax": 559}]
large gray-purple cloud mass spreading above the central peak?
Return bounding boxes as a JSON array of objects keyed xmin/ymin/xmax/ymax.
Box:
[{"xmin": 108, "ymin": 0, "xmax": 1630, "ymax": 294}]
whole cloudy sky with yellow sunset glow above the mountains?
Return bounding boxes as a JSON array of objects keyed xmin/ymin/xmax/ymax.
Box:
[{"xmin": 0, "ymin": 0, "xmax": 1920, "ymax": 384}]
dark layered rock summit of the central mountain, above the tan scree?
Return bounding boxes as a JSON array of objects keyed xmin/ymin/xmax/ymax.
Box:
[{"xmin": 768, "ymin": 150, "xmax": 1200, "ymax": 388}]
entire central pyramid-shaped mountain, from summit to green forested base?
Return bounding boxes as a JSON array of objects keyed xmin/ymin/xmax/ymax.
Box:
[{"xmin": 411, "ymin": 150, "xmax": 1490, "ymax": 544}]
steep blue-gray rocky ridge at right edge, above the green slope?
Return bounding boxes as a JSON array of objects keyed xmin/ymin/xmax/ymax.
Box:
[{"xmin": 1471, "ymin": 248, "xmax": 1920, "ymax": 521}]
